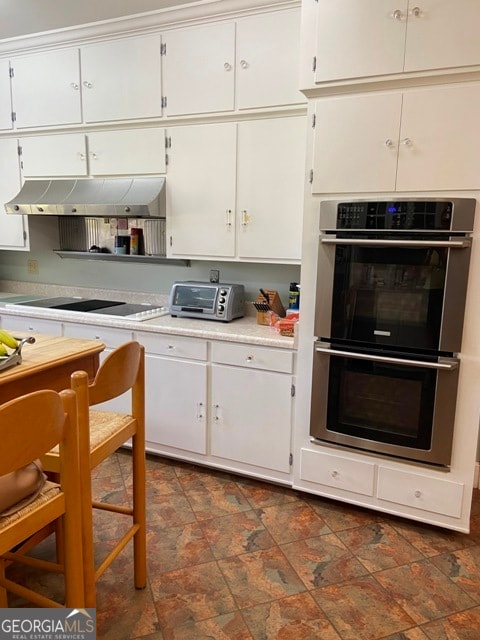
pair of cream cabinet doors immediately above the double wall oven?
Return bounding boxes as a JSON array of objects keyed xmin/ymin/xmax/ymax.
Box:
[{"xmin": 312, "ymin": 83, "xmax": 480, "ymax": 193}]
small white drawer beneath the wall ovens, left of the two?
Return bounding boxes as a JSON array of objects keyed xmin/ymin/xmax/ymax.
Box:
[{"xmin": 300, "ymin": 449, "xmax": 375, "ymax": 496}]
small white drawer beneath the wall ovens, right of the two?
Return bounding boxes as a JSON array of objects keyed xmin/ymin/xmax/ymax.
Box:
[{"xmin": 377, "ymin": 467, "xmax": 463, "ymax": 518}]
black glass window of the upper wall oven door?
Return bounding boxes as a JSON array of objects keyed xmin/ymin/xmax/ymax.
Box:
[{"xmin": 331, "ymin": 246, "xmax": 448, "ymax": 351}]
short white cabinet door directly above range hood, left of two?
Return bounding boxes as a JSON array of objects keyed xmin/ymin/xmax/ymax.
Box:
[{"xmin": 21, "ymin": 133, "xmax": 87, "ymax": 177}]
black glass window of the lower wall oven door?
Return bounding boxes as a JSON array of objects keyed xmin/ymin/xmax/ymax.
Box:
[{"xmin": 327, "ymin": 356, "xmax": 436, "ymax": 449}]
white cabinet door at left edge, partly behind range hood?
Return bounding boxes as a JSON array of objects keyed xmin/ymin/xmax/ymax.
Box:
[{"xmin": 0, "ymin": 138, "xmax": 27, "ymax": 249}]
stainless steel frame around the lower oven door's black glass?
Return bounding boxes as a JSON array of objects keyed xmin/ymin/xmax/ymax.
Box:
[{"xmin": 310, "ymin": 344, "xmax": 459, "ymax": 467}]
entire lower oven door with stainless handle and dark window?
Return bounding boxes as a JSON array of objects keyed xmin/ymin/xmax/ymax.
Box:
[{"xmin": 310, "ymin": 342, "xmax": 459, "ymax": 466}]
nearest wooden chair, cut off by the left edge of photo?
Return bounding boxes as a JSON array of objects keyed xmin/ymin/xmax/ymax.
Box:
[{"xmin": 0, "ymin": 389, "xmax": 85, "ymax": 608}]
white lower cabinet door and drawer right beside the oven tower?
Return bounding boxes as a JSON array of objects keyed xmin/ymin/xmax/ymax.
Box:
[{"xmin": 210, "ymin": 342, "xmax": 293, "ymax": 473}]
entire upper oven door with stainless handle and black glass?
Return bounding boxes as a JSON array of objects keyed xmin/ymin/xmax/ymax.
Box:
[{"xmin": 315, "ymin": 232, "xmax": 470, "ymax": 353}]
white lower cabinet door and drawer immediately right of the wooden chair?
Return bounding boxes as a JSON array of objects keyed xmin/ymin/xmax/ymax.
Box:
[{"xmin": 135, "ymin": 332, "xmax": 207, "ymax": 454}]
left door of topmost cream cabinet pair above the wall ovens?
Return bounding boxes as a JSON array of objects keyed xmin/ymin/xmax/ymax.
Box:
[{"xmin": 315, "ymin": 0, "xmax": 407, "ymax": 82}]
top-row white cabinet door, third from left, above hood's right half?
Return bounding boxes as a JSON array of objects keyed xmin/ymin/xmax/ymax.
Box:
[{"xmin": 81, "ymin": 35, "xmax": 162, "ymax": 122}]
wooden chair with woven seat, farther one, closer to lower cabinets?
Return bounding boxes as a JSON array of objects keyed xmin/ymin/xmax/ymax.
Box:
[{"xmin": 46, "ymin": 342, "xmax": 147, "ymax": 607}]
